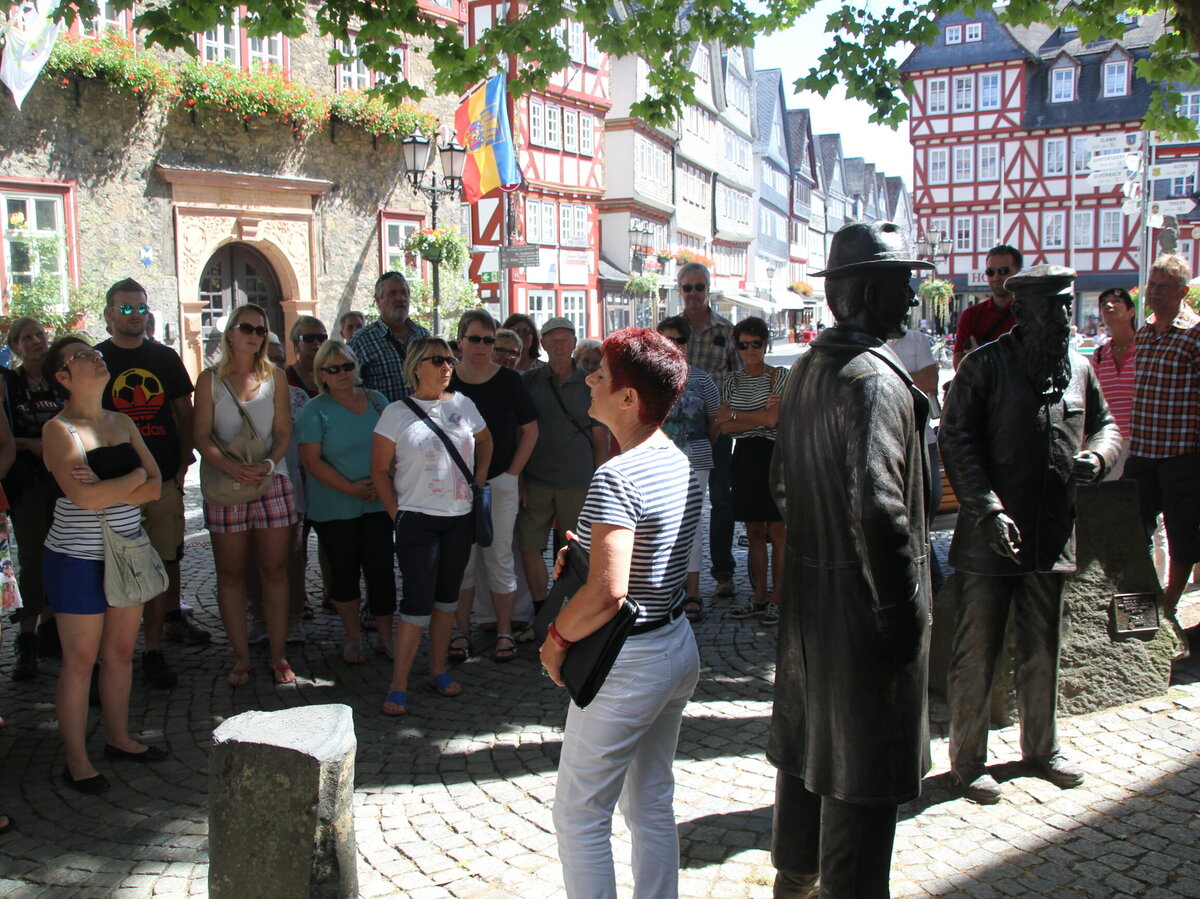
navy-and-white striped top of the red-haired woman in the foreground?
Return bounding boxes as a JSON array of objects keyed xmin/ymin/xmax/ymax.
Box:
[{"xmin": 578, "ymin": 442, "xmax": 702, "ymax": 624}]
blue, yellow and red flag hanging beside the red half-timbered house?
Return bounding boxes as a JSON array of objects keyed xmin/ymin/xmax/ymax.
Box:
[{"xmin": 455, "ymin": 72, "xmax": 521, "ymax": 203}]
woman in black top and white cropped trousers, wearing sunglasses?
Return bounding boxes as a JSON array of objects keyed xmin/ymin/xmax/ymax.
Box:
[{"xmin": 449, "ymin": 308, "xmax": 538, "ymax": 663}]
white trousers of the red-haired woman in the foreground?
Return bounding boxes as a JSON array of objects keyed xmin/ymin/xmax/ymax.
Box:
[{"xmin": 554, "ymin": 616, "xmax": 700, "ymax": 899}]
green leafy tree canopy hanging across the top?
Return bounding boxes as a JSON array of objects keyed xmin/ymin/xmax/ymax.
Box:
[{"xmin": 56, "ymin": 0, "xmax": 1200, "ymax": 134}]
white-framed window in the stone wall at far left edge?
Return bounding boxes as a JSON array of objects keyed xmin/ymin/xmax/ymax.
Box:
[{"xmin": 0, "ymin": 186, "xmax": 70, "ymax": 301}]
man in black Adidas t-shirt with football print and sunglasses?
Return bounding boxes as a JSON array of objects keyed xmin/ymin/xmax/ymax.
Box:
[{"xmin": 96, "ymin": 278, "xmax": 211, "ymax": 689}]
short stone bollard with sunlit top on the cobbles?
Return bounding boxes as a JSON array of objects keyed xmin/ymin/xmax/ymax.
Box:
[{"xmin": 209, "ymin": 705, "xmax": 359, "ymax": 899}]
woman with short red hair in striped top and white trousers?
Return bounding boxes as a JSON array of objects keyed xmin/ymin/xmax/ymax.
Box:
[{"xmin": 541, "ymin": 329, "xmax": 702, "ymax": 899}]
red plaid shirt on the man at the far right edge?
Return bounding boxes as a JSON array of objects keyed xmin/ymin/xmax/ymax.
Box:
[{"xmin": 1129, "ymin": 310, "xmax": 1200, "ymax": 459}]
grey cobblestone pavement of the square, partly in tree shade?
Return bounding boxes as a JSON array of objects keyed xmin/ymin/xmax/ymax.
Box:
[{"xmin": 0, "ymin": 501, "xmax": 1200, "ymax": 899}]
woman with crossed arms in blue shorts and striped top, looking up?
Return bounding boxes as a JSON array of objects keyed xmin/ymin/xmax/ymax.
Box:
[{"xmin": 42, "ymin": 336, "xmax": 167, "ymax": 793}]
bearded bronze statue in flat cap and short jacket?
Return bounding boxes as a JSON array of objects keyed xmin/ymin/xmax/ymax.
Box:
[{"xmin": 938, "ymin": 265, "xmax": 1121, "ymax": 803}]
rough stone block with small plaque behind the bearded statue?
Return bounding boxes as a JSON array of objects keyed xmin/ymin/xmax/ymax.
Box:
[{"xmin": 929, "ymin": 481, "xmax": 1175, "ymax": 725}]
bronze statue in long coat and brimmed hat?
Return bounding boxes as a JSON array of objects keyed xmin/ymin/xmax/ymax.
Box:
[{"xmin": 767, "ymin": 222, "xmax": 932, "ymax": 899}]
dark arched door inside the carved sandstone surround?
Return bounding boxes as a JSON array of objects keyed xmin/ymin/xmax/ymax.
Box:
[{"xmin": 198, "ymin": 241, "xmax": 287, "ymax": 365}]
